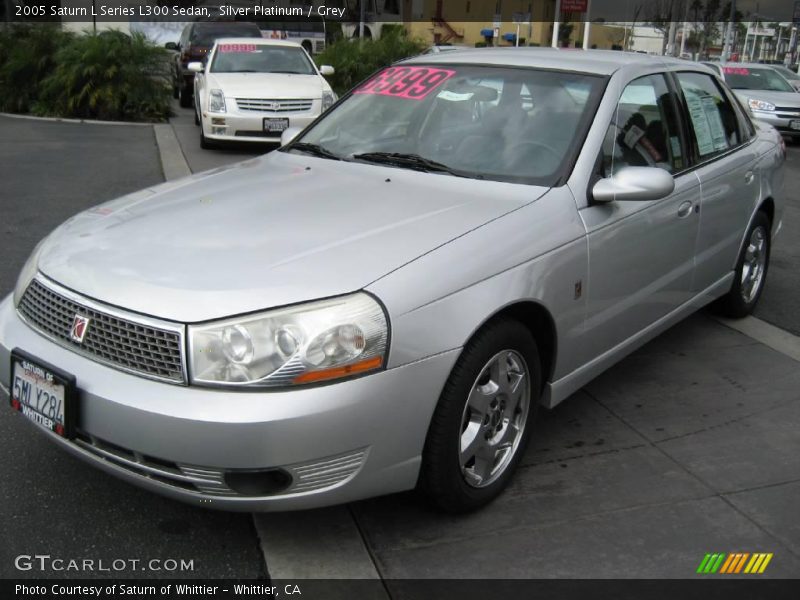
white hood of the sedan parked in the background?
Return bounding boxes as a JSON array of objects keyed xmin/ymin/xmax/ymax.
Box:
[{"xmin": 208, "ymin": 73, "xmax": 328, "ymax": 99}]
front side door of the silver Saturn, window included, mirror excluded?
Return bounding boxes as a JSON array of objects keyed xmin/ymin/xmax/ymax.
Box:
[{"xmin": 581, "ymin": 74, "xmax": 700, "ymax": 356}]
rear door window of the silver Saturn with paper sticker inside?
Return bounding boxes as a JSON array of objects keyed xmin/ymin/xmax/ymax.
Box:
[{"xmin": 677, "ymin": 72, "xmax": 742, "ymax": 160}]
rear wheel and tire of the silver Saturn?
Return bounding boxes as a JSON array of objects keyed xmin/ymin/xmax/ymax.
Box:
[{"xmin": 712, "ymin": 211, "xmax": 772, "ymax": 319}]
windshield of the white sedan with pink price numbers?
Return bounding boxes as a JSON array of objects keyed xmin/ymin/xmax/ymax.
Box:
[{"xmin": 211, "ymin": 44, "xmax": 316, "ymax": 75}]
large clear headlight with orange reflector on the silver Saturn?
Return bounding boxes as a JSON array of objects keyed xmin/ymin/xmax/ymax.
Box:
[{"xmin": 189, "ymin": 293, "xmax": 389, "ymax": 388}]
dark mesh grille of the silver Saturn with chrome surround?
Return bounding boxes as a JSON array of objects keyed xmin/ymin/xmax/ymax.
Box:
[{"xmin": 19, "ymin": 279, "xmax": 185, "ymax": 383}]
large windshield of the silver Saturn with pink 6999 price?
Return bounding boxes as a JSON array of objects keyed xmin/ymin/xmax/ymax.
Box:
[{"xmin": 288, "ymin": 64, "xmax": 605, "ymax": 185}]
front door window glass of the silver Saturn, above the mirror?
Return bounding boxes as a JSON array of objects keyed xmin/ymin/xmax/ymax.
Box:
[{"xmin": 603, "ymin": 75, "xmax": 686, "ymax": 177}]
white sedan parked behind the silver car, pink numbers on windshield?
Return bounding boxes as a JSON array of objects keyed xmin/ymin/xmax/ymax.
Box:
[{"xmin": 188, "ymin": 38, "xmax": 336, "ymax": 148}]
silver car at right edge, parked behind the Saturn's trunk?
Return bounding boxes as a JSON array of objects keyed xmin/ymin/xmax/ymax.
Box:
[{"xmin": 708, "ymin": 63, "xmax": 800, "ymax": 139}]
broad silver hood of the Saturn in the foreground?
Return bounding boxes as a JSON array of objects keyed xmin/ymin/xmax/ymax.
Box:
[{"xmin": 39, "ymin": 152, "xmax": 547, "ymax": 322}]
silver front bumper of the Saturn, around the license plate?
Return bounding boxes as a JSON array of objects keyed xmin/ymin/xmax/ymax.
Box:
[{"xmin": 0, "ymin": 296, "xmax": 458, "ymax": 511}]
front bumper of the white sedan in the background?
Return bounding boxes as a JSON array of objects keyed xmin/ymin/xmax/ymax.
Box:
[{"xmin": 201, "ymin": 98, "xmax": 322, "ymax": 144}]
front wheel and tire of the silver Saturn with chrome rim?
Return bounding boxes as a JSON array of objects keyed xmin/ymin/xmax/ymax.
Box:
[{"xmin": 419, "ymin": 318, "xmax": 542, "ymax": 513}]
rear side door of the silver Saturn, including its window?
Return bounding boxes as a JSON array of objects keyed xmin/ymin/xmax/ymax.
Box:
[{"xmin": 675, "ymin": 71, "xmax": 760, "ymax": 292}]
